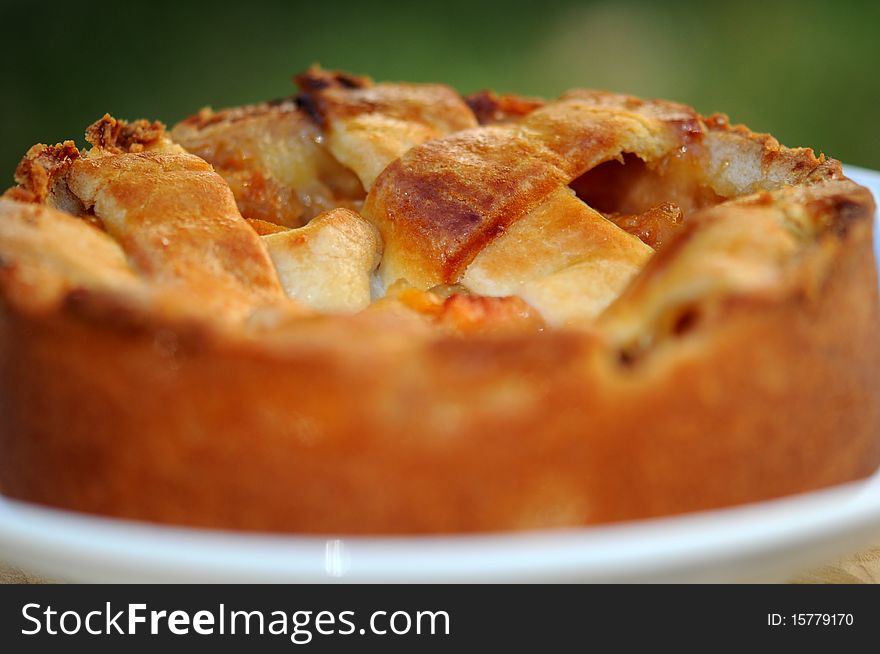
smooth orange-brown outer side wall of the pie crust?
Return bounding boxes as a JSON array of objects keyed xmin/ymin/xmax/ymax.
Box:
[{"xmin": 0, "ymin": 221, "xmax": 880, "ymax": 534}]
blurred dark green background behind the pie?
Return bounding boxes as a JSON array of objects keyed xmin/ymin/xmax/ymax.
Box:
[{"xmin": 0, "ymin": 0, "xmax": 880, "ymax": 179}]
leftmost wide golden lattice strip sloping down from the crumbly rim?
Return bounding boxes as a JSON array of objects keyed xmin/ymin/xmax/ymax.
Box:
[{"xmin": 67, "ymin": 152, "xmax": 281, "ymax": 320}]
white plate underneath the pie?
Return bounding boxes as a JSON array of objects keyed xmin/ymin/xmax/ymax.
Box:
[{"xmin": 0, "ymin": 168, "xmax": 880, "ymax": 582}]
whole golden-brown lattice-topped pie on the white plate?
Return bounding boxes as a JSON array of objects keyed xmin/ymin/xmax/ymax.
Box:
[{"xmin": 0, "ymin": 68, "xmax": 880, "ymax": 534}]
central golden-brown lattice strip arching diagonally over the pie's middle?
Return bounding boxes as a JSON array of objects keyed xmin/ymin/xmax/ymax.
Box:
[{"xmin": 364, "ymin": 98, "xmax": 696, "ymax": 287}]
